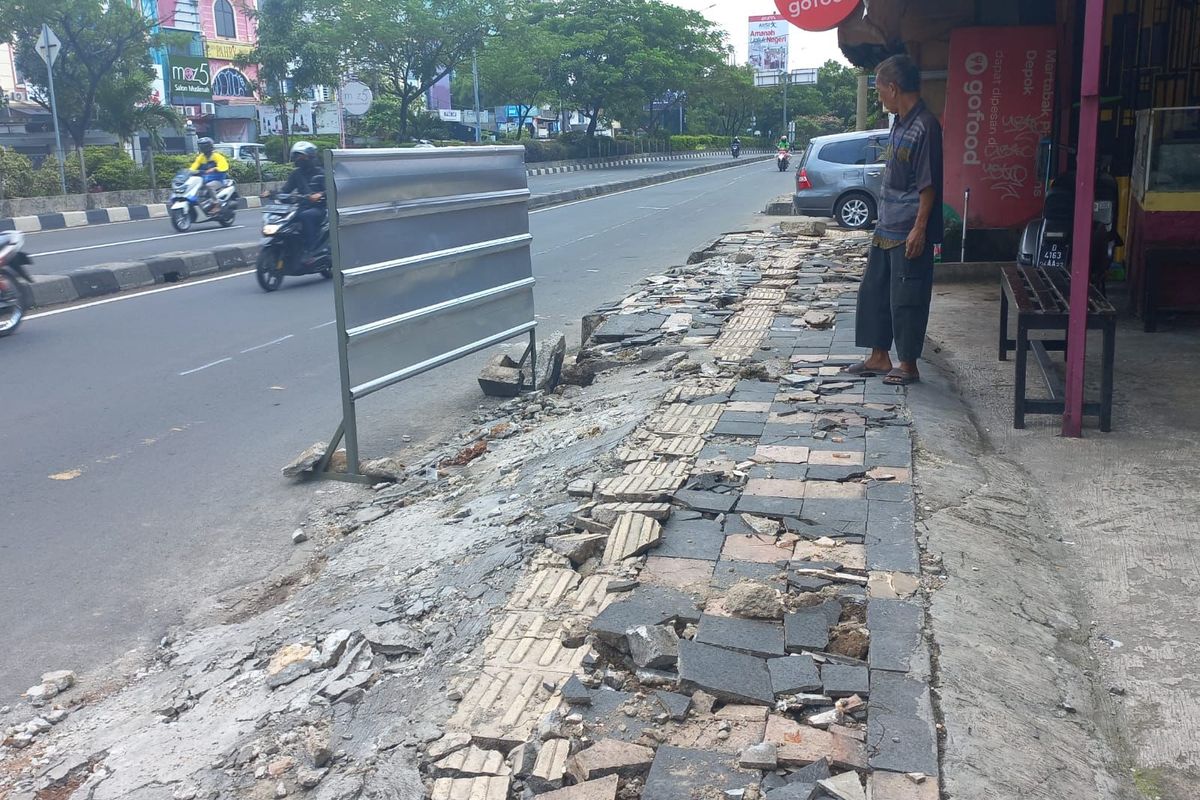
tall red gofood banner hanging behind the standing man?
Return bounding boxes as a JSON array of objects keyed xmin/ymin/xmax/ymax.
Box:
[{"xmin": 943, "ymin": 26, "xmax": 1058, "ymax": 228}]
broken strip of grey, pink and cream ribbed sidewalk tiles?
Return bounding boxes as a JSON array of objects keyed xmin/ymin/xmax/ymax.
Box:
[{"xmin": 422, "ymin": 231, "xmax": 938, "ymax": 800}]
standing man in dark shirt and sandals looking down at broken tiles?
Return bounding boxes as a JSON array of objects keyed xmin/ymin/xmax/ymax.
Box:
[{"xmin": 846, "ymin": 55, "xmax": 942, "ymax": 386}]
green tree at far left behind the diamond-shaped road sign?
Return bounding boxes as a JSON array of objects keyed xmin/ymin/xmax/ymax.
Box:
[{"xmin": 0, "ymin": 0, "xmax": 156, "ymax": 186}]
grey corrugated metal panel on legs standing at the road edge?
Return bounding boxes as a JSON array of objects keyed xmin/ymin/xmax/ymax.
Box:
[{"xmin": 318, "ymin": 146, "xmax": 536, "ymax": 480}]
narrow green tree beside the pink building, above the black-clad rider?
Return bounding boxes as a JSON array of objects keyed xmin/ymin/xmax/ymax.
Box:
[{"xmin": 238, "ymin": 0, "xmax": 344, "ymax": 149}]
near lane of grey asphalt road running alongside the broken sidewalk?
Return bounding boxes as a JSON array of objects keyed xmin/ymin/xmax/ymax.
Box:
[{"xmin": 0, "ymin": 163, "xmax": 792, "ymax": 703}]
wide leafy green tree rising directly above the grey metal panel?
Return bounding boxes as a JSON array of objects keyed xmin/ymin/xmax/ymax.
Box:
[{"xmin": 328, "ymin": 0, "xmax": 510, "ymax": 137}]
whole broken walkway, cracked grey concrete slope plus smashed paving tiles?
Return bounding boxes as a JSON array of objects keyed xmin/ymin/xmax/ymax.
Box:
[{"xmin": 0, "ymin": 224, "xmax": 938, "ymax": 800}]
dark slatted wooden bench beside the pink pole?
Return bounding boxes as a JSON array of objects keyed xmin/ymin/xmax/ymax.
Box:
[{"xmin": 1000, "ymin": 264, "xmax": 1117, "ymax": 433}]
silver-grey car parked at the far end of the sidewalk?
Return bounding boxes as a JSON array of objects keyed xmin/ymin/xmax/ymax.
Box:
[{"xmin": 793, "ymin": 131, "xmax": 888, "ymax": 230}]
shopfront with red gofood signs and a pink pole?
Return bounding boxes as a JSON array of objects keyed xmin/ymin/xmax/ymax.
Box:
[{"xmin": 839, "ymin": 0, "xmax": 1200, "ymax": 435}]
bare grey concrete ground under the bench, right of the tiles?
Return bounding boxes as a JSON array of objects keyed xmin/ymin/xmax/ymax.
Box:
[{"xmin": 910, "ymin": 283, "xmax": 1200, "ymax": 800}]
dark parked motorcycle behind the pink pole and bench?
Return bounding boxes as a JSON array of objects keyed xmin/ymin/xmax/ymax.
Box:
[{"xmin": 1016, "ymin": 170, "xmax": 1122, "ymax": 291}]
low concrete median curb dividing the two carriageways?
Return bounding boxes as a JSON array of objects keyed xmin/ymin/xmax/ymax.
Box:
[{"xmin": 30, "ymin": 156, "xmax": 768, "ymax": 308}]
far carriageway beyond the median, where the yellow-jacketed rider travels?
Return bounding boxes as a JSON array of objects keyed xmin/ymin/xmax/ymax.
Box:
[{"xmin": 26, "ymin": 155, "xmax": 730, "ymax": 275}]
